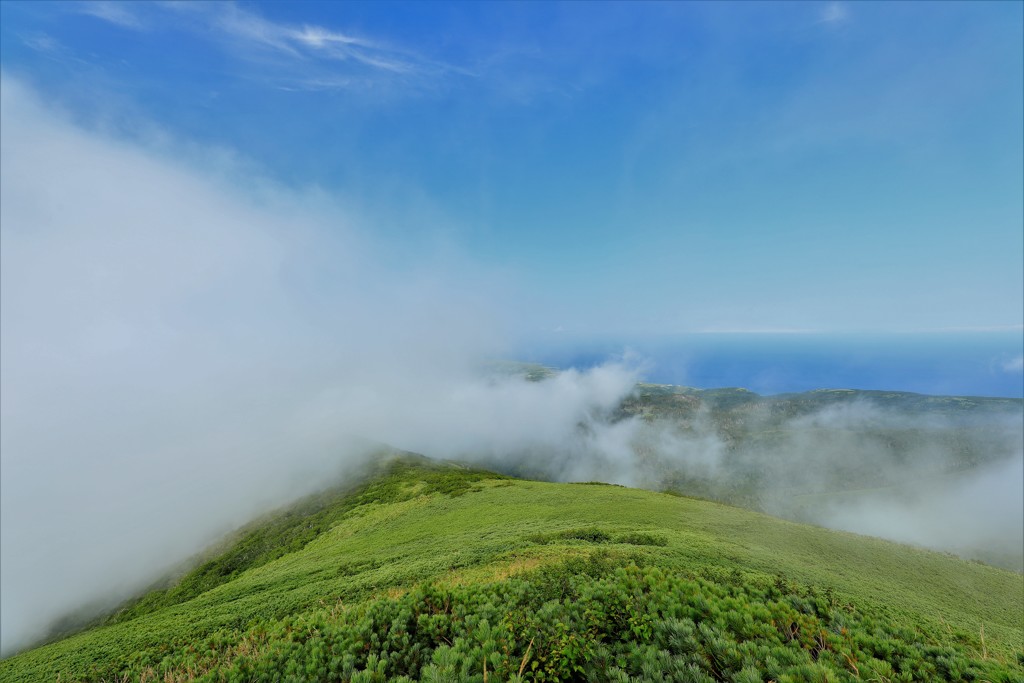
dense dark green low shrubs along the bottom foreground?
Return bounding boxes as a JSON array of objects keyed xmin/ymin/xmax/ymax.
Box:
[{"xmin": 51, "ymin": 553, "xmax": 1022, "ymax": 683}]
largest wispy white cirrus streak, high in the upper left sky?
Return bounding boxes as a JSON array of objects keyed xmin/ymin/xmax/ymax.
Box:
[{"xmin": 80, "ymin": 2, "xmax": 471, "ymax": 90}]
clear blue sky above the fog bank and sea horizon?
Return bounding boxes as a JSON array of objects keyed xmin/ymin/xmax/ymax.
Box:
[{"xmin": 0, "ymin": 1, "xmax": 1024, "ymax": 335}]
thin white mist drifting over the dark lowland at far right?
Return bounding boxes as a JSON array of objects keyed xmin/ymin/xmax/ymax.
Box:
[{"xmin": 734, "ymin": 400, "xmax": 1024, "ymax": 570}]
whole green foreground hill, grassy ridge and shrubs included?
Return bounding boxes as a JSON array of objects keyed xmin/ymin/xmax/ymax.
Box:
[{"xmin": 0, "ymin": 459, "xmax": 1024, "ymax": 682}]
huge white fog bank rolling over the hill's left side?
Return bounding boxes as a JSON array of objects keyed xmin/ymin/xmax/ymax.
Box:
[{"xmin": 0, "ymin": 75, "xmax": 1019, "ymax": 655}]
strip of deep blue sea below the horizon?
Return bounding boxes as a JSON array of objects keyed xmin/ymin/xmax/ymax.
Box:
[{"xmin": 520, "ymin": 331, "xmax": 1024, "ymax": 398}]
